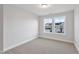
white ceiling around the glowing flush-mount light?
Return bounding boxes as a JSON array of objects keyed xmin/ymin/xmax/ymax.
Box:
[{"xmin": 11, "ymin": 4, "xmax": 76, "ymax": 16}]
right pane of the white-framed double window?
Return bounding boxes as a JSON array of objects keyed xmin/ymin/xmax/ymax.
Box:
[{"xmin": 54, "ymin": 16, "xmax": 65, "ymax": 33}]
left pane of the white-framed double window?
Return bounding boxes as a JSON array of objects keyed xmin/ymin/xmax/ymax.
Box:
[{"xmin": 44, "ymin": 18, "xmax": 52, "ymax": 32}]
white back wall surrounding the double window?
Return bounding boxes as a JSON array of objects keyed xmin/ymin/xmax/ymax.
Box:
[{"xmin": 39, "ymin": 11, "xmax": 74, "ymax": 42}]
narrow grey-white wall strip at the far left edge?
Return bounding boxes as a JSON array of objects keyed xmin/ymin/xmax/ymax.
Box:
[{"xmin": 0, "ymin": 4, "xmax": 3, "ymax": 52}]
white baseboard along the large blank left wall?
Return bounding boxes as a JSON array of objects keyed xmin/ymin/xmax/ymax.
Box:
[{"xmin": 3, "ymin": 35, "xmax": 38, "ymax": 52}]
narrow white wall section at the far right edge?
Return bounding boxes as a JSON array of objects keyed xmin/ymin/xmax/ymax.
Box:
[{"xmin": 74, "ymin": 5, "xmax": 79, "ymax": 51}]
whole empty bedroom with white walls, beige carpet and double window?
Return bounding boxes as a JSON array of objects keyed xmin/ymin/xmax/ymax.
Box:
[{"xmin": 0, "ymin": 4, "xmax": 79, "ymax": 54}]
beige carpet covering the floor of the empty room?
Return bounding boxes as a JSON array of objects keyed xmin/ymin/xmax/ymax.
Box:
[{"xmin": 5, "ymin": 38, "xmax": 78, "ymax": 54}]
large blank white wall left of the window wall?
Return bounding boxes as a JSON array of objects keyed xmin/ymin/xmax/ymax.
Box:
[{"xmin": 4, "ymin": 5, "xmax": 38, "ymax": 50}]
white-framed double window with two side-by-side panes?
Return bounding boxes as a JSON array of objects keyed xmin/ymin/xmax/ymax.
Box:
[{"xmin": 44, "ymin": 16, "xmax": 65, "ymax": 33}]
